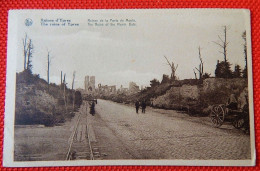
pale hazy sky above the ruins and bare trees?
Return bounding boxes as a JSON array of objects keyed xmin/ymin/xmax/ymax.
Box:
[{"xmin": 16, "ymin": 10, "xmax": 250, "ymax": 88}]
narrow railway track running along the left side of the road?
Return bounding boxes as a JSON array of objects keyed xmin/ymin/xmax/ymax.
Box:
[{"xmin": 66, "ymin": 103, "xmax": 94, "ymax": 160}]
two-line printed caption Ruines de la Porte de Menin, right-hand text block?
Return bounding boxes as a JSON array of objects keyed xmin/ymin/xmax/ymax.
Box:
[{"xmin": 88, "ymin": 19, "xmax": 136, "ymax": 27}]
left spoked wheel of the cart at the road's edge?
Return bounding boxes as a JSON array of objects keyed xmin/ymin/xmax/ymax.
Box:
[{"xmin": 210, "ymin": 105, "xmax": 225, "ymax": 128}]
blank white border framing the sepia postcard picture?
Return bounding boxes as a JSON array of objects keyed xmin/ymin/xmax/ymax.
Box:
[{"xmin": 3, "ymin": 9, "xmax": 256, "ymax": 167}]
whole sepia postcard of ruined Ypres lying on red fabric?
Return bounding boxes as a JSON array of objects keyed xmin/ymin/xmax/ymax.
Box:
[{"xmin": 3, "ymin": 9, "xmax": 256, "ymax": 167}]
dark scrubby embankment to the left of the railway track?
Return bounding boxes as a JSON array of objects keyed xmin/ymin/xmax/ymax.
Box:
[{"xmin": 15, "ymin": 70, "xmax": 82, "ymax": 126}]
